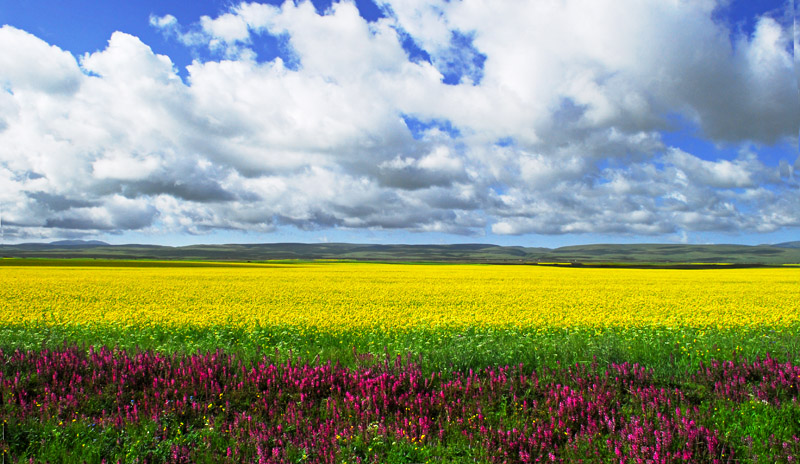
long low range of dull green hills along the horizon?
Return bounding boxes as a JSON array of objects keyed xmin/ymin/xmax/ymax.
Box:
[{"xmin": 0, "ymin": 240, "xmax": 800, "ymax": 266}]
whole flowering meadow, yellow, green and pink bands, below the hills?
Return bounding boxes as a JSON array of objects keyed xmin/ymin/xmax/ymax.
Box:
[{"xmin": 0, "ymin": 260, "xmax": 800, "ymax": 463}]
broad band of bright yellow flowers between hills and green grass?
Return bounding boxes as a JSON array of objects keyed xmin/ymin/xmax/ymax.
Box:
[{"xmin": 0, "ymin": 263, "xmax": 800, "ymax": 331}]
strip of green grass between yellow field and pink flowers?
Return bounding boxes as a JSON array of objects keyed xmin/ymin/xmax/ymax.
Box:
[{"xmin": 0, "ymin": 323, "xmax": 800, "ymax": 377}]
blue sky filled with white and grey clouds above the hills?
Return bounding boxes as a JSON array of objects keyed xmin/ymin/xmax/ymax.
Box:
[{"xmin": 0, "ymin": 0, "xmax": 800, "ymax": 247}]
